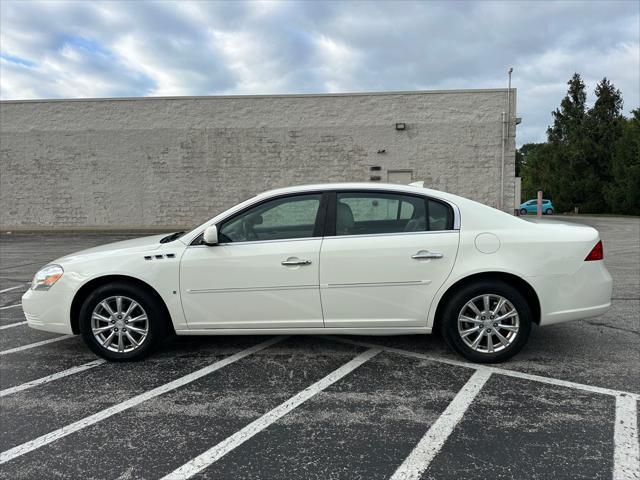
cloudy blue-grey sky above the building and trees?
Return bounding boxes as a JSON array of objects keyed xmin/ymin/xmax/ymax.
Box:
[{"xmin": 0, "ymin": 0, "xmax": 640, "ymax": 144}]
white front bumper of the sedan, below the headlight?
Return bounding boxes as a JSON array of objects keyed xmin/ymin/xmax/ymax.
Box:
[{"xmin": 22, "ymin": 280, "xmax": 73, "ymax": 334}]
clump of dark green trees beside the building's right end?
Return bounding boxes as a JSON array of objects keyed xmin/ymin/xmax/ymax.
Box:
[{"xmin": 518, "ymin": 73, "xmax": 640, "ymax": 213}]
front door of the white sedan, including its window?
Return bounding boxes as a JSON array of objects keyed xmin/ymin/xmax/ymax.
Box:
[{"xmin": 180, "ymin": 193, "xmax": 326, "ymax": 329}]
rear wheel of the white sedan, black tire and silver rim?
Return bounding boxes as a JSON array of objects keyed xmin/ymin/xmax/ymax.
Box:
[{"xmin": 441, "ymin": 281, "xmax": 533, "ymax": 363}]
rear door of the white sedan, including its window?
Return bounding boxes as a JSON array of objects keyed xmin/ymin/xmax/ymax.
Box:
[{"xmin": 320, "ymin": 191, "xmax": 459, "ymax": 328}]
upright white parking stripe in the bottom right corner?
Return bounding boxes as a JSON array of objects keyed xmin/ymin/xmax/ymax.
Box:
[{"xmin": 613, "ymin": 395, "xmax": 640, "ymax": 480}]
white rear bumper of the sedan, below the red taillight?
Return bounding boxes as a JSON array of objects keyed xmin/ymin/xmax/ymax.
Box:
[{"xmin": 528, "ymin": 261, "xmax": 613, "ymax": 325}]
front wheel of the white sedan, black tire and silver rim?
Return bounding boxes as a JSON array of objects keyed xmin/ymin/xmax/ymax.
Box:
[{"xmin": 80, "ymin": 282, "xmax": 169, "ymax": 362}]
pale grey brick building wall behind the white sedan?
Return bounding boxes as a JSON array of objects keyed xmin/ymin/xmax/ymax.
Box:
[{"xmin": 0, "ymin": 89, "xmax": 516, "ymax": 230}]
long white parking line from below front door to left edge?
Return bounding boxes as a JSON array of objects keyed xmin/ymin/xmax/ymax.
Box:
[{"xmin": 0, "ymin": 337, "xmax": 286, "ymax": 464}]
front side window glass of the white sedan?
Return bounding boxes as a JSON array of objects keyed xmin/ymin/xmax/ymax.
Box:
[{"xmin": 219, "ymin": 194, "xmax": 322, "ymax": 243}]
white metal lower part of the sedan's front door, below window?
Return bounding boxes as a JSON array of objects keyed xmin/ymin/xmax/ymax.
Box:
[{"xmin": 180, "ymin": 238, "xmax": 323, "ymax": 329}]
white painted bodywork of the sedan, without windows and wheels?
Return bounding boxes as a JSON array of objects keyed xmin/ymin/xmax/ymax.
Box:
[{"xmin": 22, "ymin": 183, "xmax": 612, "ymax": 335}]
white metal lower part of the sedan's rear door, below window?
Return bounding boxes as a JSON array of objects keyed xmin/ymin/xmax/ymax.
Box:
[{"xmin": 320, "ymin": 230, "xmax": 459, "ymax": 328}]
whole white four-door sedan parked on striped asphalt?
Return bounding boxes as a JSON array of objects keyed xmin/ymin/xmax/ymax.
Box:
[{"xmin": 22, "ymin": 183, "xmax": 612, "ymax": 362}]
